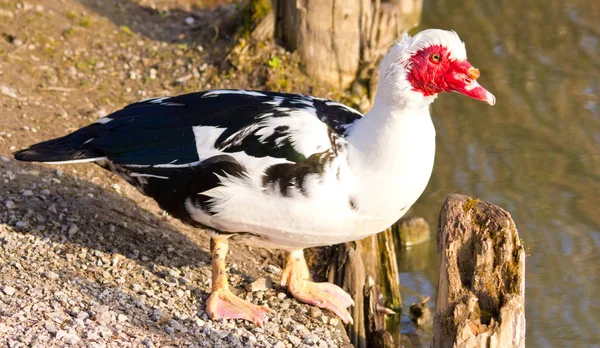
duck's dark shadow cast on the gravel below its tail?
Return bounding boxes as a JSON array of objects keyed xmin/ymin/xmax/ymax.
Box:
[{"xmin": 0, "ymin": 160, "xmax": 210, "ymax": 268}]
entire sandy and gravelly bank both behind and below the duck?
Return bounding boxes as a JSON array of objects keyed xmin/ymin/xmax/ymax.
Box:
[{"xmin": 0, "ymin": 0, "xmax": 349, "ymax": 347}]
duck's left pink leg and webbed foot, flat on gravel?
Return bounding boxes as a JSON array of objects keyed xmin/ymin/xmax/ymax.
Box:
[{"xmin": 206, "ymin": 238, "xmax": 269, "ymax": 326}]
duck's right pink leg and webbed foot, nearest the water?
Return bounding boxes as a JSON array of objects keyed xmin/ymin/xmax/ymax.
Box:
[{"xmin": 281, "ymin": 250, "xmax": 354, "ymax": 324}]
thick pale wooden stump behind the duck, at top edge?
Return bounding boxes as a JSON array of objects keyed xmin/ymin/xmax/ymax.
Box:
[{"xmin": 274, "ymin": 0, "xmax": 422, "ymax": 88}]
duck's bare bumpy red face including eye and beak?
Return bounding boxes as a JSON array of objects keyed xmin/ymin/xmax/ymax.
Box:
[{"xmin": 408, "ymin": 45, "xmax": 496, "ymax": 105}]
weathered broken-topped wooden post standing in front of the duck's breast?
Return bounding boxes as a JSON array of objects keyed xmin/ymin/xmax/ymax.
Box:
[{"xmin": 433, "ymin": 194, "xmax": 525, "ymax": 348}]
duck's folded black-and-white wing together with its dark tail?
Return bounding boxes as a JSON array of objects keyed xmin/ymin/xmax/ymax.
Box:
[{"xmin": 15, "ymin": 90, "xmax": 361, "ymax": 223}]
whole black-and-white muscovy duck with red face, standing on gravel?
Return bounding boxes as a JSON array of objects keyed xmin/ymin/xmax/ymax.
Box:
[{"xmin": 14, "ymin": 29, "xmax": 495, "ymax": 325}]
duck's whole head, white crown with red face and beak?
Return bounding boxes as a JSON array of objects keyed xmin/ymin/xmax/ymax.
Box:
[{"xmin": 377, "ymin": 29, "xmax": 496, "ymax": 105}]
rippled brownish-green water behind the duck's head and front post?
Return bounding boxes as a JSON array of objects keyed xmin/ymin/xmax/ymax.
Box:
[{"xmin": 400, "ymin": 0, "xmax": 600, "ymax": 347}]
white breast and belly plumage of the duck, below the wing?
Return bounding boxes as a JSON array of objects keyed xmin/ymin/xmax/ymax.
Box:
[{"xmin": 187, "ymin": 103, "xmax": 435, "ymax": 250}]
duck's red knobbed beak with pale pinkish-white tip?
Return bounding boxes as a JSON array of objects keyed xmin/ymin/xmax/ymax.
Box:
[{"xmin": 445, "ymin": 60, "xmax": 496, "ymax": 105}]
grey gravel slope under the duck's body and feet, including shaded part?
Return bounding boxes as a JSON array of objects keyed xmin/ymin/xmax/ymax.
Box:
[{"xmin": 0, "ymin": 156, "xmax": 349, "ymax": 348}]
